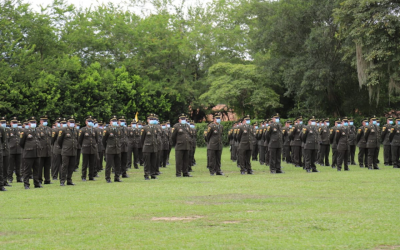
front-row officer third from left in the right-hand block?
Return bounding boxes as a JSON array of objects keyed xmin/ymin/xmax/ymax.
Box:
[{"xmin": 300, "ymin": 117, "xmax": 319, "ymax": 173}]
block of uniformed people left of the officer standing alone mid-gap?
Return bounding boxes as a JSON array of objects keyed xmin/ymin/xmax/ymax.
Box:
[{"xmin": 0, "ymin": 114, "xmax": 196, "ymax": 191}]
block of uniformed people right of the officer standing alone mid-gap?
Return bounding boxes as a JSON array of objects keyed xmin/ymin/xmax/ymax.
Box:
[{"xmin": 228, "ymin": 114, "xmax": 400, "ymax": 174}]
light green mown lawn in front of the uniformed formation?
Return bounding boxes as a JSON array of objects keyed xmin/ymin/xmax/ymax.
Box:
[{"xmin": 0, "ymin": 148, "xmax": 400, "ymax": 249}]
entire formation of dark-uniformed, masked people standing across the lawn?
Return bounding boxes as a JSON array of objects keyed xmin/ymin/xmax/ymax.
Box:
[{"xmin": 0, "ymin": 114, "xmax": 400, "ymax": 191}]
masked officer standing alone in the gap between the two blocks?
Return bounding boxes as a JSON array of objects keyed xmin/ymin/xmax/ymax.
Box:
[{"xmin": 206, "ymin": 113, "xmax": 224, "ymax": 175}]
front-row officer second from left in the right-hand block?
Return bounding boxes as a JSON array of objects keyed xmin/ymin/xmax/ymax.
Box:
[{"xmin": 266, "ymin": 114, "xmax": 284, "ymax": 174}]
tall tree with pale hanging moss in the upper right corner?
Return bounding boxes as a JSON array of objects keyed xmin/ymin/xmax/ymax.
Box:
[{"xmin": 334, "ymin": 0, "xmax": 400, "ymax": 103}]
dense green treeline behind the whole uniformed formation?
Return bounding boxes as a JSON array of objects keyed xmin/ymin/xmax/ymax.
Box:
[{"xmin": 0, "ymin": 0, "xmax": 400, "ymax": 122}]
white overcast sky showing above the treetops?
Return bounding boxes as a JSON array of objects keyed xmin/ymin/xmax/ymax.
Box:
[{"xmin": 25, "ymin": 0, "xmax": 216, "ymax": 14}]
